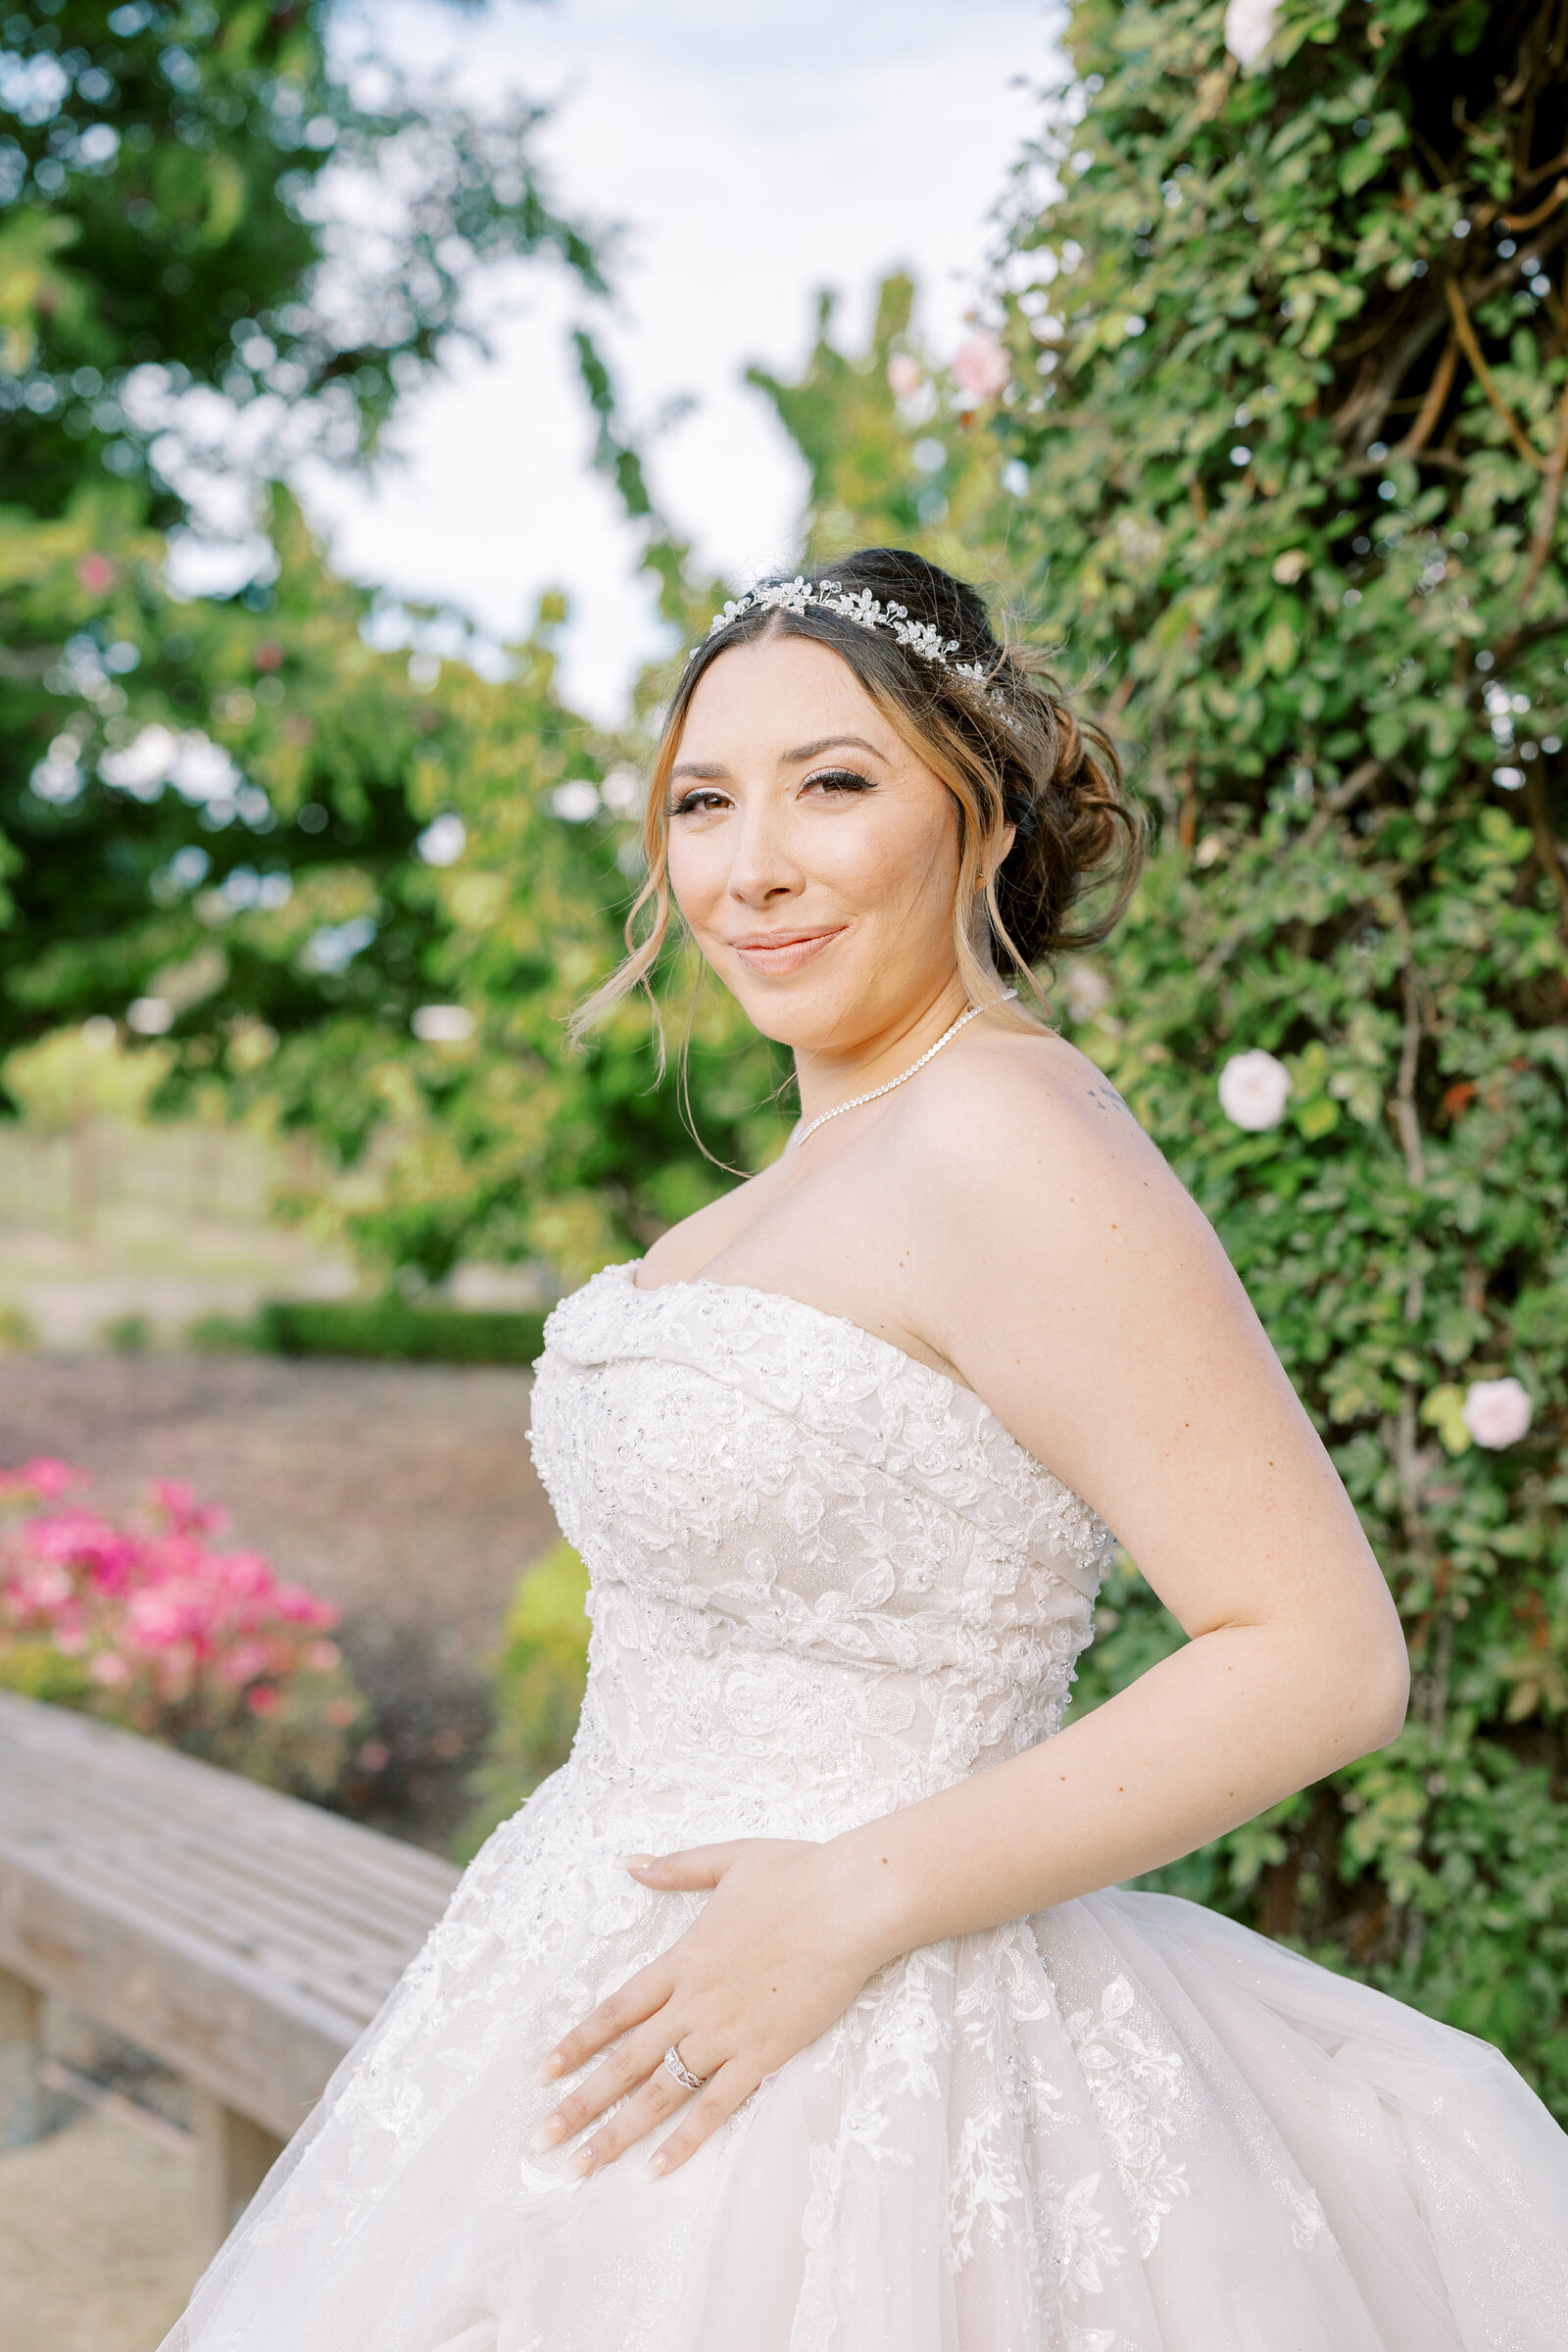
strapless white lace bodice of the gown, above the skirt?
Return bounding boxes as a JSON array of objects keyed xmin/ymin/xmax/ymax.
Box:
[{"xmin": 531, "ymin": 1265, "xmax": 1109, "ymax": 1835}]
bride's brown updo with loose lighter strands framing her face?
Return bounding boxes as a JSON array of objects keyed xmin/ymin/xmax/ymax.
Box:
[{"xmin": 571, "ymin": 548, "xmax": 1143, "ymax": 1040}]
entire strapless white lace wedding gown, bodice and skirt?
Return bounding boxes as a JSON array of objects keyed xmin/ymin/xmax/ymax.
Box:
[{"xmin": 167, "ymin": 1265, "xmax": 1568, "ymax": 2352}]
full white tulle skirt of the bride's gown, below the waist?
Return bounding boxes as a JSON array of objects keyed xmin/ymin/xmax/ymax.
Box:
[{"xmin": 165, "ymin": 1766, "xmax": 1568, "ymax": 2352}]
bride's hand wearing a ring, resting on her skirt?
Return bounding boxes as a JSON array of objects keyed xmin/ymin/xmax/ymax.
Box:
[{"xmin": 534, "ymin": 1837, "xmax": 889, "ymax": 2178}]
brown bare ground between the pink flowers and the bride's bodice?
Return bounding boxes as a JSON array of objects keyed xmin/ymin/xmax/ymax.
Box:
[{"xmin": 0, "ymin": 1354, "xmax": 555, "ymax": 1846}]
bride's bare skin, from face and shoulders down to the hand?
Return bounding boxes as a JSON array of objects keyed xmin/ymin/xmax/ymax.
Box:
[{"xmin": 536, "ymin": 640, "xmax": 1408, "ymax": 2178}]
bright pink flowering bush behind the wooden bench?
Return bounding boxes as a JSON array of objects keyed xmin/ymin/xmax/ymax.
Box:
[{"xmin": 0, "ymin": 1456, "xmax": 367, "ymax": 1797}]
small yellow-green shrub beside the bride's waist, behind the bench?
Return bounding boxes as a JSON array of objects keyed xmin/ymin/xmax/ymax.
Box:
[{"xmin": 459, "ymin": 1543, "xmax": 588, "ymax": 1860}]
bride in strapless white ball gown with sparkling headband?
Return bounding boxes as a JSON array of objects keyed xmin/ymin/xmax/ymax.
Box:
[{"xmin": 170, "ymin": 551, "xmax": 1568, "ymax": 2352}]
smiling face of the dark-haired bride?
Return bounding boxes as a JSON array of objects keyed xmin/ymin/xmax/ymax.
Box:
[{"xmin": 670, "ymin": 637, "xmax": 987, "ymax": 1054}]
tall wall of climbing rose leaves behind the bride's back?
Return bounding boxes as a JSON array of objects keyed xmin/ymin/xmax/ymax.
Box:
[{"xmin": 987, "ymin": 0, "xmax": 1568, "ymax": 2115}]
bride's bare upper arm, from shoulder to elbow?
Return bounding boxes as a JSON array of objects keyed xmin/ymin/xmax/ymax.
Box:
[{"xmin": 906, "ymin": 1047, "xmax": 1398, "ymax": 1648}]
